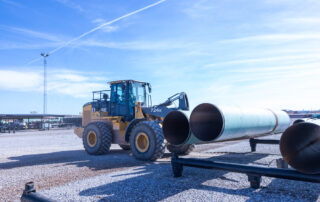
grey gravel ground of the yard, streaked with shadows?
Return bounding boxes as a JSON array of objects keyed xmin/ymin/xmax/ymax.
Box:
[{"xmin": 0, "ymin": 130, "xmax": 320, "ymax": 202}]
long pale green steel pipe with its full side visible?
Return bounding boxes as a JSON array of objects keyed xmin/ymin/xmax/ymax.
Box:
[{"xmin": 190, "ymin": 103, "xmax": 290, "ymax": 142}]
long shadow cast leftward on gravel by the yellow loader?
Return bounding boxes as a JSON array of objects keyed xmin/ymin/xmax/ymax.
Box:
[{"xmin": 0, "ymin": 149, "xmax": 144, "ymax": 170}]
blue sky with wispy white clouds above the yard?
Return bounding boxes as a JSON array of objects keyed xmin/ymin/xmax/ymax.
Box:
[{"xmin": 0, "ymin": 0, "xmax": 320, "ymax": 114}]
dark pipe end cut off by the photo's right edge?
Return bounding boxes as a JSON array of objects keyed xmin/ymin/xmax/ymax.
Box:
[{"xmin": 280, "ymin": 122, "xmax": 320, "ymax": 174}]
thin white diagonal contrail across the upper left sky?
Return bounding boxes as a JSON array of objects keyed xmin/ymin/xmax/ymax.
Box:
[{"xmin": 27, "ymin": 0, "xmax": 166, "ymax": 65}]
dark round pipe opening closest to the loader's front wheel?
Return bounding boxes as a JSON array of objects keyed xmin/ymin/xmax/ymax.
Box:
[{"xmin": 162, "ymin": 111, "xmax": 189, "ymax": 145}]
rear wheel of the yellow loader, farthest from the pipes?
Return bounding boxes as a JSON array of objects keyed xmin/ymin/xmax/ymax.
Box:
[{"xmin": 82, "ymin": 122, "xmax": 112, "ymax": 155}]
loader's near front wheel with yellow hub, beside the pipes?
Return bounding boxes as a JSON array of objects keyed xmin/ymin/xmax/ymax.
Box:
[{"xmin": 130, "ymin": 121, "xmax": 165, "ymax": 161}]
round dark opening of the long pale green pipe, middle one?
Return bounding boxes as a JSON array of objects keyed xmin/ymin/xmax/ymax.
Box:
[{"xmin": 190, "ymin": 103, "xmax": 224, "ymax": 141}]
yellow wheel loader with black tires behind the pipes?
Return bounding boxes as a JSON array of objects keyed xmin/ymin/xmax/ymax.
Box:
[{"xmin": 74, "ymin": 80, "xmax": 194, "ymax": 161}]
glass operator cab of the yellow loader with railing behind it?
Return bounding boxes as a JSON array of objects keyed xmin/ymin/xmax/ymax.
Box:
[{"xmin": 92, "ymin": 80, "xmax": 152, "ymax": 121}]
